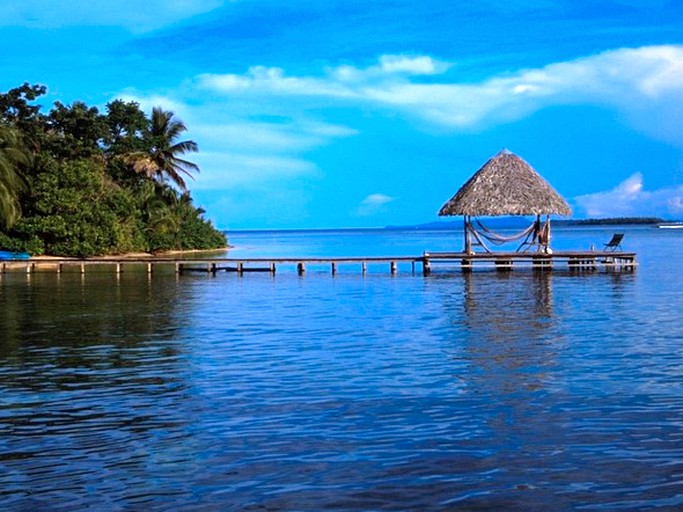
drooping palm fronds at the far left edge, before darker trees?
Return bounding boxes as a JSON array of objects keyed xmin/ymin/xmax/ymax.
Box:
[{"xmin": 0, "ymin": 126, "xmax": 30, "ymax": 230}]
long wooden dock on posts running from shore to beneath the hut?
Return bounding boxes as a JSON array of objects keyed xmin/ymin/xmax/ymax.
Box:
[{"xmin": 0, "ymin": 251, "xmax": 637, "ymax": 276}]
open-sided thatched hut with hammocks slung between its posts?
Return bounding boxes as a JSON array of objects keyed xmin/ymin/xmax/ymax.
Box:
[{"xmin": 439, "ymin": 149, "xmax": 571, "ymax": 253}]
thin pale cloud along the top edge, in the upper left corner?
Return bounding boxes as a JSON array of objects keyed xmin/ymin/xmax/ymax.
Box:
[{"xmin": 0, "ymin": 0, "xmax": 229, "ymax": 32}]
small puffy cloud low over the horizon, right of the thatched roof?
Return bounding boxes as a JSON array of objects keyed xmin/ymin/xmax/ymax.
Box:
[{"xmin": 574, "ymin": 173, "xmax": 683, "ymax": 218}]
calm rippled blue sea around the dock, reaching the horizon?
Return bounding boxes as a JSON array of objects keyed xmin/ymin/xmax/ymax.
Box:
[{"xmin": 0, "ymin": 227, "xmax": 683, "ymax": 511}]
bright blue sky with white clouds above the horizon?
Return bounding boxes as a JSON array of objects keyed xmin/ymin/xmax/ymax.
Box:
[{"xmin": 0, "ymin": 0, "xmax": 683, "ymax": 229}]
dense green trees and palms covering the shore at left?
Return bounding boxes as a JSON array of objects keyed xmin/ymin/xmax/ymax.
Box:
[{"xmin": 0, "ymin": 84, "xmax": 227, "ymax": 257}]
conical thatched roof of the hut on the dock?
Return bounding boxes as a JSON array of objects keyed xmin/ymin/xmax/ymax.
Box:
[{"xmin": 439, "ymin": 149, "xmax": 571, "ymax": 216}]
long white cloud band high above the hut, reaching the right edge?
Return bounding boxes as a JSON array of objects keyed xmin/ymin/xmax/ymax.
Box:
[{"xmin": 197, "ymin": 45, "xmax": 683, "ymax": 145}]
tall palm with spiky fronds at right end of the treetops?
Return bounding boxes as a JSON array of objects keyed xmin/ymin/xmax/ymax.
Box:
[{"xmin": 126, "ymin": 107, "xmax": 199, "ymax": 192}]
